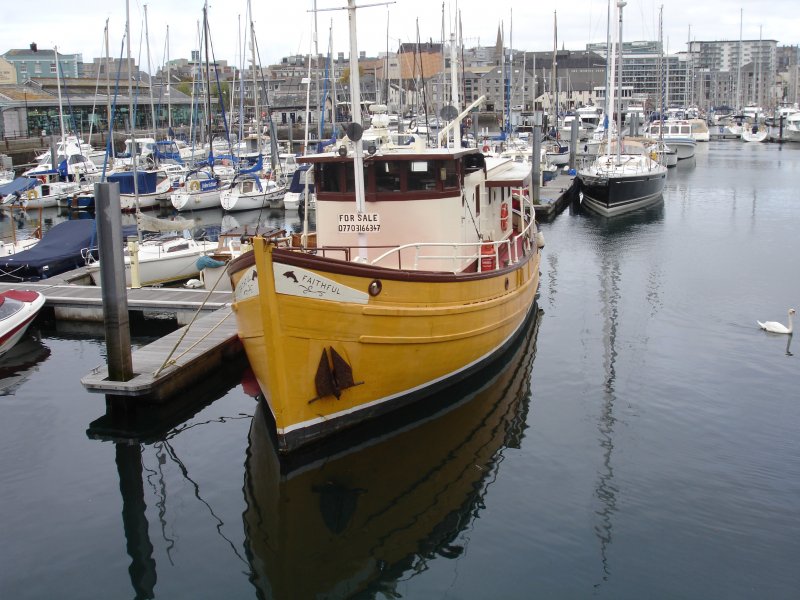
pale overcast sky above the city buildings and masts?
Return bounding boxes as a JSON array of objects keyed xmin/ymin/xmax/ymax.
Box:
[{"xmin": 0, "ymin": 0, "xmax": 800, "ymax": 70}]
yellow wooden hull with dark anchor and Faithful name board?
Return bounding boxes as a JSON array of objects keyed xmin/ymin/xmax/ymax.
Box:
[{"xmin": 229, "ymin": 239, "xmax": 540, "ymax": 451}]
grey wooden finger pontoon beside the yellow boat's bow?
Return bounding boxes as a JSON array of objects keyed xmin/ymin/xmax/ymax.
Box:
[{"xmin": 81, "ymin": 306, "xmax": 242, "ymax": 403}]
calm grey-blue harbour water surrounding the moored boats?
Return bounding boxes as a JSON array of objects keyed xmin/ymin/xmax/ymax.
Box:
[{"xmin": 0, "ymin": 141, "xmax": 800, "ymax": 599}]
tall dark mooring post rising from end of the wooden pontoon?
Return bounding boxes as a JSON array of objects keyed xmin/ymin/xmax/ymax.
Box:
[{"xmin": 94, "ymin": 182, "xmax": 133, "ymax": 381}]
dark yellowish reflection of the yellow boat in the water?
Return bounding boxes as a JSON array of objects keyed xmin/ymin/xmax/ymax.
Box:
[{"xmin": 244, "ymin": 307, "xmax": 541, "ymax": 598}]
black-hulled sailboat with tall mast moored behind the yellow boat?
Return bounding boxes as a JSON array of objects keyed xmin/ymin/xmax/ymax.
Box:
[{"xmin": 578, "ymin": 0, "xmax": 667, "ymax": 216}]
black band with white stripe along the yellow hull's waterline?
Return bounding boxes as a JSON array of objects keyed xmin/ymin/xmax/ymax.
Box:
[{"xmin": 267, "ymin": 300, "xmax": 537, "ymax": 454}]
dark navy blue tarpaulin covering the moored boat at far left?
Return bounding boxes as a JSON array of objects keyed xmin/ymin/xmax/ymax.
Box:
[{"xmin": 0, "ymin": 219, "xmax": 97, "ymax": 281}]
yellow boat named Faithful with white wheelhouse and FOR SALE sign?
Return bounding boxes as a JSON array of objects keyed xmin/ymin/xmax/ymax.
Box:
[{"xmin": 228, "ymin": 0, "xmax": 541, "ymax": 453}]
